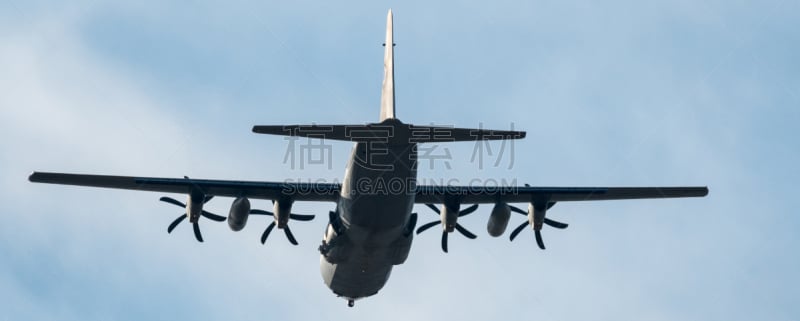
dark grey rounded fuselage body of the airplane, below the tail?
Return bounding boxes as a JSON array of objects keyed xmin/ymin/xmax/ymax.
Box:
[{"xmin": 320, "ymin": 142, "xmax": 417, "ymax": 300}]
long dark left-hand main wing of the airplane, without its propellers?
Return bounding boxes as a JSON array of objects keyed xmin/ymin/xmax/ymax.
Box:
[{"xmin": 28, "ymin": 172, "xmax": 340, "ymax": 202}]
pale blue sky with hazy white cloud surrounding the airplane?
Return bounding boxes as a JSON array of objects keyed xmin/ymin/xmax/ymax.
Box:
[{"xmin": 0, "ymin": 0, "xmax": 800, "ymax": 320}]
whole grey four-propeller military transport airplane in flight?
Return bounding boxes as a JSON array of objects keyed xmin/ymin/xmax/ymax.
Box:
[{"xmin": 29, "ymin": 10, "xmax": 708, "ymax": 306}]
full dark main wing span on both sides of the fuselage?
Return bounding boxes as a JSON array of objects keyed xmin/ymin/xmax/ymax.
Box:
[{"xmin": 28, "ymin": 172, "xmax": 708, "ymax": 204}]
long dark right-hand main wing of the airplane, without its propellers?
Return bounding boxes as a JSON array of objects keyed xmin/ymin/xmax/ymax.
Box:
[{"xmin": 415, "ymin": 185, "xmax": 708, "ymax": 204}]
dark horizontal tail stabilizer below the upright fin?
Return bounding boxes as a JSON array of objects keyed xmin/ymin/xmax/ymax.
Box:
[{"xmin": 253, "ymin": 119, "xmax": 525, "ymax": 144}]
